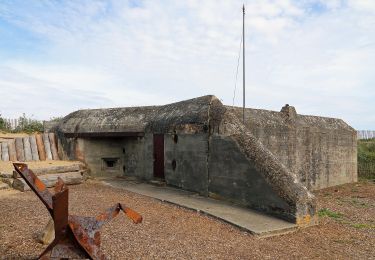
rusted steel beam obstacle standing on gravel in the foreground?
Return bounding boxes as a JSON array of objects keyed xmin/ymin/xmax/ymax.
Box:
[{"xmin": 13, "ymin": 163, "xmax": 142, "ymax": 259}]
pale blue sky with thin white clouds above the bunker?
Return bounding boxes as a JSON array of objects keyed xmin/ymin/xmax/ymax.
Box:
[{"xmin": 0, "ymin": 0, "xmax": 375, "ymax": 129}]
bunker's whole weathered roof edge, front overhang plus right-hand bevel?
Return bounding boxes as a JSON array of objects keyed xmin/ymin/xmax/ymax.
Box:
[{"xmin": 57, "ymin": 95, "xmax": 354, "ymax": 137}]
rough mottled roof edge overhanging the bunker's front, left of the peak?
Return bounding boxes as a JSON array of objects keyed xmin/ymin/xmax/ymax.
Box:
[{"xmin": 58, "ymin": 96, "xmax": 216, "ymax": 136}]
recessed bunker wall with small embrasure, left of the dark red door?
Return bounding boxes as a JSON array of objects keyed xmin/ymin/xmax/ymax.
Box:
[{"xmin": 59, "ymin": 135, "xmax": 153, "ymax": 179}]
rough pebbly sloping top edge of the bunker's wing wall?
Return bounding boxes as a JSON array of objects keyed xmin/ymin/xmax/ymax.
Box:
[{"xmin": 219, "ymin": 111, "xmax": 316, "ymax": 225}]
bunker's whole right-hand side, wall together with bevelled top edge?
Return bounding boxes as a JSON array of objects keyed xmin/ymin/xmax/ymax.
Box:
[{"xmin": 227, "ymin": 105, "xmax": 357, "ymax": 190}]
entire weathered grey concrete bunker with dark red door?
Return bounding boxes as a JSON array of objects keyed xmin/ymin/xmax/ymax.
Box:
[{"xmin": 51, "ymin": 96, "xmax": 357, "ymax": 225}]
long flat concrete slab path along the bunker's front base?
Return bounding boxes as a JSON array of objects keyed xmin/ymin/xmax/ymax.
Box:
[{"xmin": 102, "ymin": 179, "xmax": 297, "ymax": 237}]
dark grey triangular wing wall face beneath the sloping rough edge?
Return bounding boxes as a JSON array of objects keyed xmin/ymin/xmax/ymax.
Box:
[{"xmin": 208, "ymin": 135, "xmax": 290, "ymax": 214}]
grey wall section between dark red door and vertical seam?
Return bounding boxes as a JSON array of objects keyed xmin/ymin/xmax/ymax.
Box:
[{"xmin": 164, "ymin": 133, "xmax": 208, "ymax": 196}]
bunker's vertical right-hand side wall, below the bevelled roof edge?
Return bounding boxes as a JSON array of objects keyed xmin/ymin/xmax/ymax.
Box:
[{"xmin": 249, "ymin": 125, "xmax": 357, "ymax": 190}]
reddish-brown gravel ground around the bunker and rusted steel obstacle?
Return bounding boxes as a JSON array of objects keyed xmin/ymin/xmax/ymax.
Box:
[{"xmin": 0, "ymin": 181, "xmax": 375, "ymax": 259}]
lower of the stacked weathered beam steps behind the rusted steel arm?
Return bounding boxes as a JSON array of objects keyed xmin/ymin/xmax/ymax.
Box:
[{"xmin": 13, "ymin": 171, "xmax": 84, "ymax": 191}]
